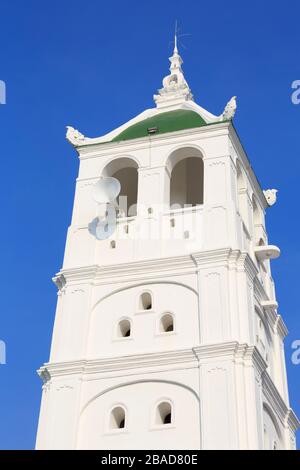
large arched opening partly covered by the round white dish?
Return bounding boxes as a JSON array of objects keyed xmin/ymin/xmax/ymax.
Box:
[{"xmin": 103, "ymin": 157, "xmax": 138, "ymax": 217}]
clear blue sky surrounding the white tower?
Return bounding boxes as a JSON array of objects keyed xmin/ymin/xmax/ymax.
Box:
[{"xmin": 0, "ymin": 0, "xmax": 300, "ymax": 449}]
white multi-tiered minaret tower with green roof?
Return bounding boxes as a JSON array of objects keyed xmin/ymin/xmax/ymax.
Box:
[{"xmin": 37, "ymin": 38, "xmax": 299, "ymax": 449}]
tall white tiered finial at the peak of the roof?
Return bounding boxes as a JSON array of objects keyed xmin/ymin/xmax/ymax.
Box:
[{"xmin": 154, "ymin": 21, "xmax": 193, "ymax": 108}]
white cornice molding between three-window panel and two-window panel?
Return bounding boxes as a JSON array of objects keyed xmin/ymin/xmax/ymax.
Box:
[{"xmin": 37, "ymin": 342, "xmax": 300, "ymax": 431}]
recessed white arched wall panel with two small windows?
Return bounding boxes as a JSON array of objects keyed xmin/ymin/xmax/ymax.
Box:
[{"xmin": 77, "ymin": 379, "xmax": 200, "ymax": 450}]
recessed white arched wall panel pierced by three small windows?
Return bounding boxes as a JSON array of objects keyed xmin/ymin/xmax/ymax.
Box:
[{"xmin": 87, "ymin": 282, "xmax": 199, "ymax": 358}]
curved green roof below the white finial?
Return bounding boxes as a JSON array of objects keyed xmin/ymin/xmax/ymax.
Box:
[{"xmin": 111, "ymin": 109, "xmax": 207, "ymax": 142}]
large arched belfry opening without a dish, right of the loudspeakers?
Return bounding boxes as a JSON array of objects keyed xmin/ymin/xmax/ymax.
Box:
[{"xmin": 167, "ymin": 147, "xmax": 204, "ymax": 208}]
